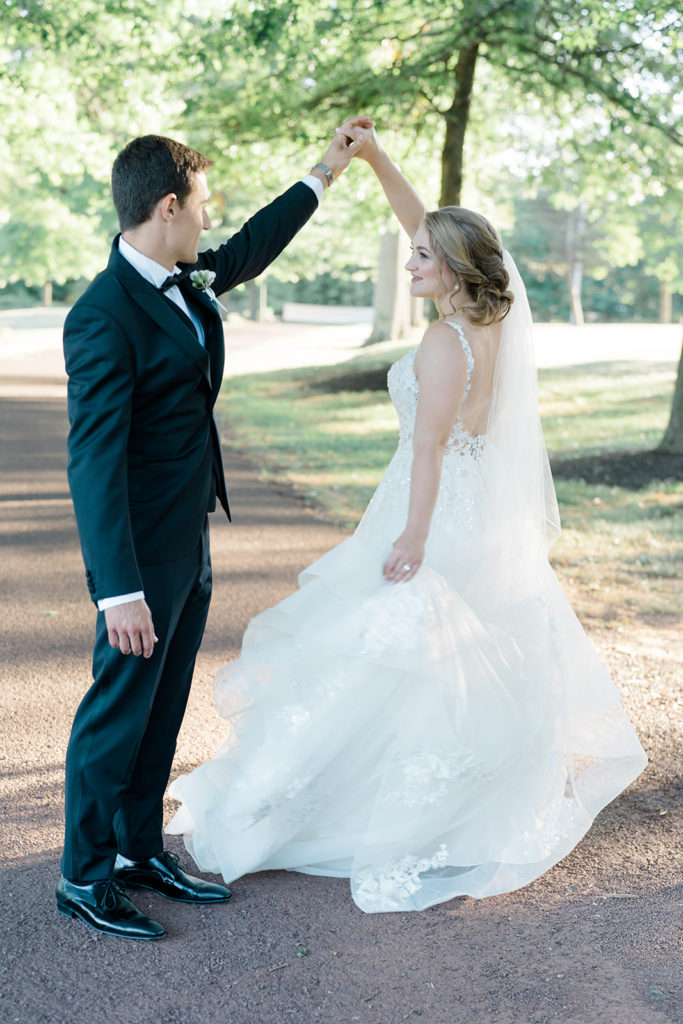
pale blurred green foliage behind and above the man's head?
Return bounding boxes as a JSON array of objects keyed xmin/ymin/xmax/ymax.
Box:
[{"xmin": 0, "ymin": 0, "xmax": 200, "ymax": 286}]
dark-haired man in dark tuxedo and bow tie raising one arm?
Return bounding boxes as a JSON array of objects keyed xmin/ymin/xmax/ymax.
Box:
[{"xmin": 56, "ymin": 125, "xmax": 362, "ymax": 939}]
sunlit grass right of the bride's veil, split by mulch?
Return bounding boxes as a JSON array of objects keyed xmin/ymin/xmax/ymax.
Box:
[{"xmin": 540, "ymin": 362, "xmax": 683, "ymax": 628}]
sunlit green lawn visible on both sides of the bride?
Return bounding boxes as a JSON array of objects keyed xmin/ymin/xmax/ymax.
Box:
[{"xmin": 219, "ymin": 343, "xmax": 683, "ymax": 629}]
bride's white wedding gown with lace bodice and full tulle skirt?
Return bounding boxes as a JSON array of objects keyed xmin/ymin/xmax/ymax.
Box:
[{"xmin": 167, "ymin": 324, "xmax": 645, "ymax": 912}]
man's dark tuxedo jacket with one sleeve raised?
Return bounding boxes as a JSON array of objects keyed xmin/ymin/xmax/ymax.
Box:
[{"xmin": 63, "ymin": 182, "xmax": 317, "ymax": 602}]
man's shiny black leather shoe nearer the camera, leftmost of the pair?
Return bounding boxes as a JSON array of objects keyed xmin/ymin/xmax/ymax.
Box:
[{"xmin": 56, "ymin": 877, "xmax": 166, "ymax": 939}]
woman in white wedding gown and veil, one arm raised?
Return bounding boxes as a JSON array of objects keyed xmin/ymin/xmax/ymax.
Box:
[{"xmin": 167, "ymin": 118, "xmax": 646, "ymax": 912}]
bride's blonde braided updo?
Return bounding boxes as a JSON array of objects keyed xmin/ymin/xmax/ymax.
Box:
[{"xmin": 424, "ymin": 206, "xmax": 514, "ymax": 325}]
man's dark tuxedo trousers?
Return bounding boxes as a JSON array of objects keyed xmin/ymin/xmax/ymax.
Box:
[{"xmin": 61, "ymin": 522, "xmax": 211, "ymax": 884}]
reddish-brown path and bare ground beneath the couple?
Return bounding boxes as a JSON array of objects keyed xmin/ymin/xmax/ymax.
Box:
[{"xmin": 0, "ymin": 329, "xmax": 683, "ymax": 1024}]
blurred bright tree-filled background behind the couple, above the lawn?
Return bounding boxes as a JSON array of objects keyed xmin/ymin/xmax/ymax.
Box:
[{"xmin": 0, "ymin": 0, "xmax": 683, "ymax": 323}]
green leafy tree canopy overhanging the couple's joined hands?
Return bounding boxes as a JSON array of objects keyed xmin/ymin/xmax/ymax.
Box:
[{"xmin": 188, "ymin": 0, "xmax": 680, "ymax": 178}]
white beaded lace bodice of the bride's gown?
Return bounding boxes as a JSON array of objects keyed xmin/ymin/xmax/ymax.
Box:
[{"xmin": 387, "ymin": 321, "xmax": 485, "ymax": 459}]
